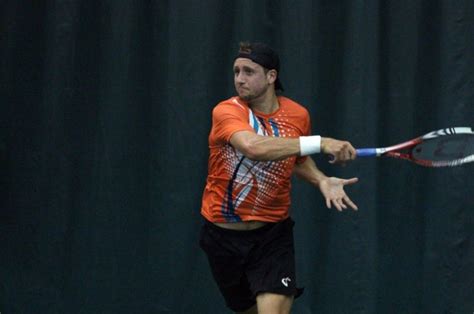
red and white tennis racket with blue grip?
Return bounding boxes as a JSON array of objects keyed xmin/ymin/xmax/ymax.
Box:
[{"xmin": 356, "ymin": 127, "xmax": 474, "ymax": 167}]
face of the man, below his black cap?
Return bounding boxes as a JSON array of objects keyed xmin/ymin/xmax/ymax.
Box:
[{"xmin": 234, "ymin": 58, "xmax": 274, "ymax": 101}]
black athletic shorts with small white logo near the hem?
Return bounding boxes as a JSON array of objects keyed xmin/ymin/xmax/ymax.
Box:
[{"xmin": 200, "ymin": 218, "xmax": 303, "ymax": 312}]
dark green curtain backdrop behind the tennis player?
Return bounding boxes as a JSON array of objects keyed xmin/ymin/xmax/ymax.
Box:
[{"xmin": 0, "ymin": 0, "xmax": 474, "ymax": 314}]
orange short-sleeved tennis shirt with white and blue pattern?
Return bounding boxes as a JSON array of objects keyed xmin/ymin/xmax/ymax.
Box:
[{"xmin": 201, "ymin": 96, "xmax": 311, "ymax": 222}]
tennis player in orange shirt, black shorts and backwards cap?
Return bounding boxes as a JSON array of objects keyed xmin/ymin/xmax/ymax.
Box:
[{"xmin": 200, "ymin": 43, "xmax": 357, "ymax": 314}]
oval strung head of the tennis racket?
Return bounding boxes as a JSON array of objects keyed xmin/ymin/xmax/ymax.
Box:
[{"xmin": 408, "ymin": 127, "xmax": 474, "ymax": 167}]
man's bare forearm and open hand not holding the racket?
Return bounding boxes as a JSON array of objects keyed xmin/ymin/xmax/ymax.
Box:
[{"xmin": 293, "ymin": 156, "xmax": 358, "ymax": 211}]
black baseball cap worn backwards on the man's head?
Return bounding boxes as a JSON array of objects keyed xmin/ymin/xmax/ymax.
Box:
[{"xmin": 235, "ymin": 43, "xmax": 283, "ymax": 91}]
